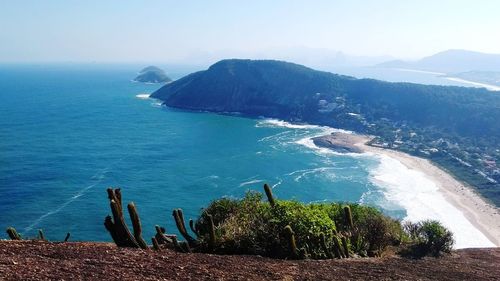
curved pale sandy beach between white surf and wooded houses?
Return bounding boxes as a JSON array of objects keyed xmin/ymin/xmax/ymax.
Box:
[{"xmin": 314, "ymin": 133, "xmax": 500, "ymax": 247}]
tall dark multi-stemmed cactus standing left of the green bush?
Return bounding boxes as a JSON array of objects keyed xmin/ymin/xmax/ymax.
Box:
[{"xmin": 104, "ymin": 188, "xmax": 139, "ymax": 248}]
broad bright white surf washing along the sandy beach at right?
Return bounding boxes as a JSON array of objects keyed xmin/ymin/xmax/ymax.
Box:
[{"xmin": 370, "ymin": 155, "xmax": 495, "ymax": 249}]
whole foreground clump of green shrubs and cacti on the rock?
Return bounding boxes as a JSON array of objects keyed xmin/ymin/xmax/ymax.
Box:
[{"xmin": 99, "ymin": 184, "xmax": 454, "ymax": 259}]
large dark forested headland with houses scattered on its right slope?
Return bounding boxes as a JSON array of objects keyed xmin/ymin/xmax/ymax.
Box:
[{"xmin": 151, "ymin": 60, "xmax": 500, "ymax": 206}]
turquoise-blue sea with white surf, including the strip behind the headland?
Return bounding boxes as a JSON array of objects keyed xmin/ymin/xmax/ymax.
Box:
[{"xmin": 0, "ymin": 63, "xmax": 493, "ymax": 248}]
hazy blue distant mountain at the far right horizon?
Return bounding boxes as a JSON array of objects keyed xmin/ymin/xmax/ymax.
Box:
[{"xmin": 377, "ymin": 50, "xmax": 500, "ymax": 74}]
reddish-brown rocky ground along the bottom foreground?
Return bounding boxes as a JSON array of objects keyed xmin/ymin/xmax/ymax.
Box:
[{"xmin": 0, "ymin": 241, "xmax": 500, "ymax": 280}]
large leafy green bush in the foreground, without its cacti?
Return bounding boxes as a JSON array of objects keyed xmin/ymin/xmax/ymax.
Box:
[{"xmin": 196, "ymin": 188, "xmax": 402, "ymax": 258}]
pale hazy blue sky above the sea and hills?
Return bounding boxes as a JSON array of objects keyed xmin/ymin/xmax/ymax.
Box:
[{"xmin": 0, "ymin": 0, "xmax": 500, "ymax": 62}]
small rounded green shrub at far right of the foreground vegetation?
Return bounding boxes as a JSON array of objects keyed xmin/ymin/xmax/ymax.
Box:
[{"xmin": 403, "ymin": 220, "xmax": 455, "ymax": 257}]
